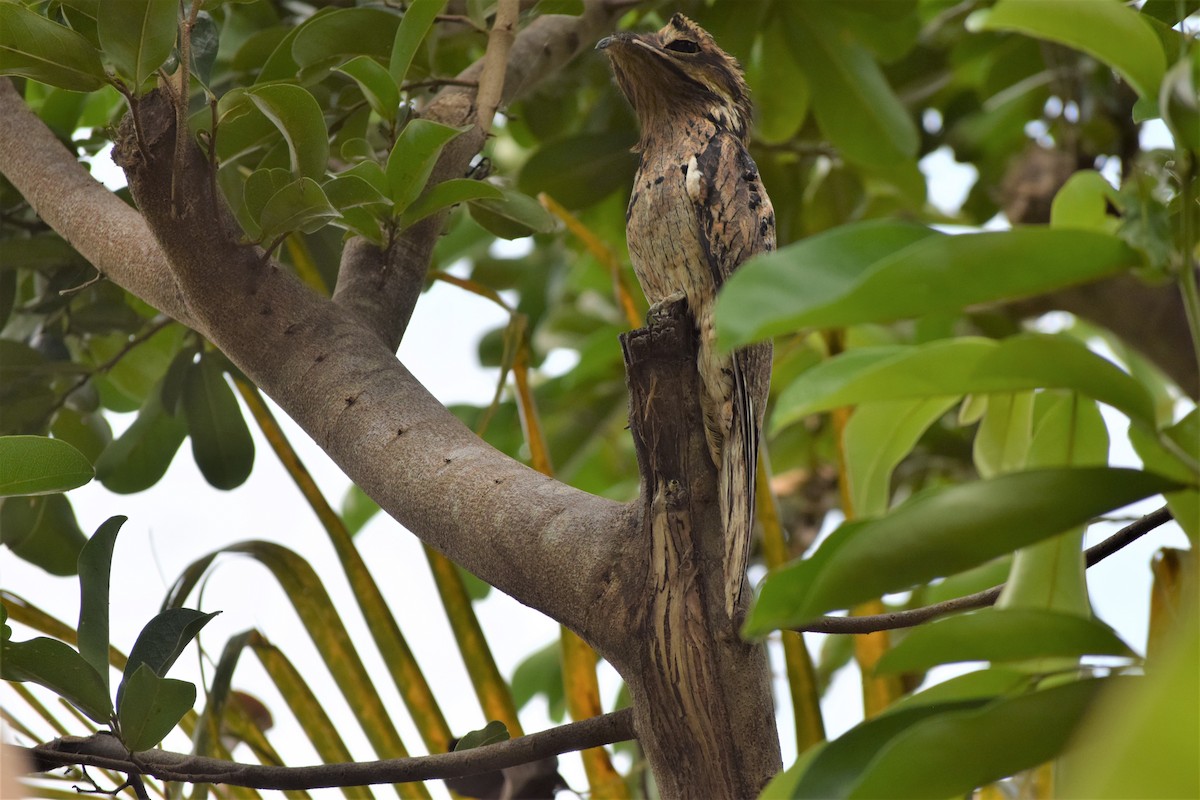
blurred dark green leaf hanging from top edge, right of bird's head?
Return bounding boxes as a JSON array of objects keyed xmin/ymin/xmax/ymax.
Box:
[{"xmin": 784, "ymin": 2, "xmax": 919, "ymax": 167}]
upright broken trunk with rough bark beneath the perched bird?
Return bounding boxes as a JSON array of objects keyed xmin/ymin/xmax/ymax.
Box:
[{"xmin": 606, "ymin": 301, "xmax": 780, "ymax": 798}]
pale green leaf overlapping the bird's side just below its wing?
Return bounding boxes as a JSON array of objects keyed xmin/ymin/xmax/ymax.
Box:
[{"xmin": 716, "ymin": 219, "xmax": 941, "ymax": 348}]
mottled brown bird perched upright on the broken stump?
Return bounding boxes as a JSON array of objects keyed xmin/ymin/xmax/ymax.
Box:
[{"xmin": 596, "ymin": 13, "xmax": 775, "ymax": 619}]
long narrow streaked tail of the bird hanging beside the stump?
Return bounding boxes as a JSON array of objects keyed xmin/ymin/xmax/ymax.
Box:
[{"xmin": 719, "ymin": 353, "xmax": 758, "ymax": 619}]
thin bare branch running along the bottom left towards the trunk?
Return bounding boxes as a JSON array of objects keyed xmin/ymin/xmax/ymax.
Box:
[{"xmin": 25, "ymin": 709, "xmax": 635, "ymax": 790}]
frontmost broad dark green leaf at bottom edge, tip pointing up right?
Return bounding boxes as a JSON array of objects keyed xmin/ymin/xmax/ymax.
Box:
[{"xmin": 841, "ymin": 679, "xmax": 1120, "ymax": 798}]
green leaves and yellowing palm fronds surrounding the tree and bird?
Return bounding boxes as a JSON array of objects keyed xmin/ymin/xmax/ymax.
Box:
[{"xmin": 0, "ymin": 0, "xmax": 1200, "ymax": 798}]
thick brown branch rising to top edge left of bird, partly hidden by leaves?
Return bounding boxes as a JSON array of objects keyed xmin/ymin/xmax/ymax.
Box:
[{"xmin": 334, "ymin": 0, "xmax": 629, "ymax": 350}]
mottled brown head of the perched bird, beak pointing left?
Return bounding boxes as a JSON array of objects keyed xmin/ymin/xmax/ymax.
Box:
[{"xmin": 596, "ymin": 14, "xmax": 750, "ymax": 139}]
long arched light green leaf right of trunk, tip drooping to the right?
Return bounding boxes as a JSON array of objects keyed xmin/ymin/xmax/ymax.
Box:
[{"xmin": 772, "ymin": 333, "xmax": 1154, "ymax": 431}]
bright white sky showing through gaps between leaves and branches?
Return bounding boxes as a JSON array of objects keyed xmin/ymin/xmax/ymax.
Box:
[{"xmin": 0, "ymin": 120, "xmax": 1187, "ymax": 798}]
